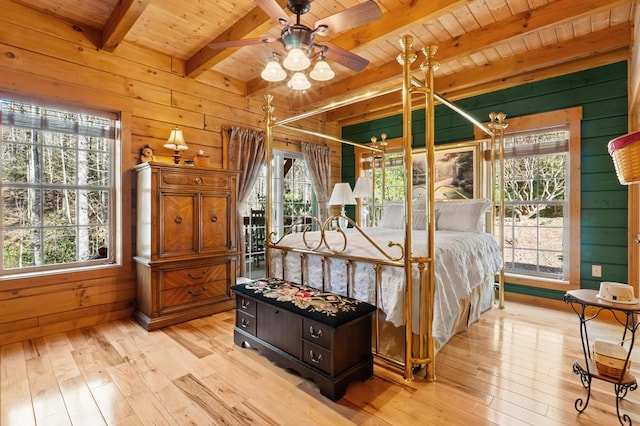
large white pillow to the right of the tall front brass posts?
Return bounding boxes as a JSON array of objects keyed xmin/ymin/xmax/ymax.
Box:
[{"xmin": 434, "ymin": 200, "xmax": 491, "ymax": 232}]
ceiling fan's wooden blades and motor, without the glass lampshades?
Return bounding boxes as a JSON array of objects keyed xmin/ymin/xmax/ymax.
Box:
[{"xmin": 209, "ymin": 0, "xmax": 382, "ymax": 75}]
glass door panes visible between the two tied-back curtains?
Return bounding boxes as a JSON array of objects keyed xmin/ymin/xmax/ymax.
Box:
[{"xmin": 243, "ymin": 151, "xmax": 317, "ymax": 278}]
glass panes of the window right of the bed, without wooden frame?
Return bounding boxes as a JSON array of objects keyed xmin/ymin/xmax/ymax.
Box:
[{"xmin": 504, "ymin": 128, "xmax": 571, "ymax": 280}]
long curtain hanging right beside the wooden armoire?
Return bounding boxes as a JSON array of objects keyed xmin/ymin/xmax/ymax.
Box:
[{"xmin": 229, "ymin": 127, "xmax": 267, "ymax": 277}]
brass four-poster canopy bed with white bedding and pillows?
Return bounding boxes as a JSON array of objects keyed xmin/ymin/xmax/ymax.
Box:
[{"xmin": 264, "ymin": 36, "xmax": 506, "ymax": 380}]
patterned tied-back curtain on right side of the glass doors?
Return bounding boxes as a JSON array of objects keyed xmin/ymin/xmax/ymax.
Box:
[{"xmin": 300, "ymin": 142, "xmax": 331, "ymax": 222}]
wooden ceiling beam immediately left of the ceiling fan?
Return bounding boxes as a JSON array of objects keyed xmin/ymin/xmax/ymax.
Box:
[{"xmin": 186, "ymin": 0, "xmax": 287, "ymax": 78}]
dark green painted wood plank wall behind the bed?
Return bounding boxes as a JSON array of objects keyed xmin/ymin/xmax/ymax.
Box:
[{"xmin": 342, "ymin": 62, "xmax": 628, "ymax": 300}]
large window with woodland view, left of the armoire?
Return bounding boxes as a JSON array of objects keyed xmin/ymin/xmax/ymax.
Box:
[{"xmin": 0, "ymin": 100, "xmax": 119, "ymax": 274}]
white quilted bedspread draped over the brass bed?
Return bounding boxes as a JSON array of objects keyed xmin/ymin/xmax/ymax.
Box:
[{"xmin": 271, "ymin": 227, "xmax": 502, "ymax": 340}]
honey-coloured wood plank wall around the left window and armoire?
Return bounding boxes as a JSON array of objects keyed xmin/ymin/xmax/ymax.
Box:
[{"xmin": 0, "ymin": 1, "xmax": 341, "ymax": 344}]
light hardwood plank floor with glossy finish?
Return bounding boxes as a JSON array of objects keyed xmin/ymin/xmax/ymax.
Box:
[{"xmin": 0, "ymin": 301, "xmax": 640, "ymax": 426}]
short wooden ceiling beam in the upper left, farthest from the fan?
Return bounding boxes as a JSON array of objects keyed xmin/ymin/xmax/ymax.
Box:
[{"xmin": 100, "ymin": 0, "xmax": 151, "ymax": 53}]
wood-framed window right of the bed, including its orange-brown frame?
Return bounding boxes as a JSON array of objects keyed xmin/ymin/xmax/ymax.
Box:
[{"xmin": 480, "ymin": 108, "xmax": 581, "ymax": 289}]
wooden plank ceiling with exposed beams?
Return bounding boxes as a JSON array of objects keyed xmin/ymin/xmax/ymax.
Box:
[{"xmin": 16, "ymin": 0, "xmax": 636, "ymax": 121}]
